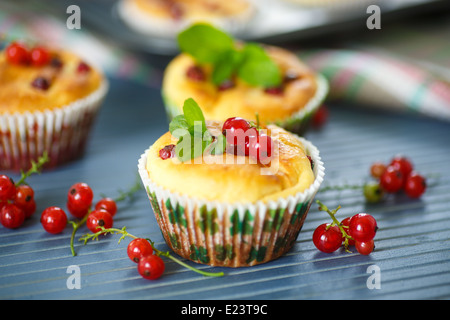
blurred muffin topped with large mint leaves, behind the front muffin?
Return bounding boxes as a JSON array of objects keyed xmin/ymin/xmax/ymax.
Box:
[{"xmin": 162, "ymin": 24, "xmax": 328, "ymax": 135}]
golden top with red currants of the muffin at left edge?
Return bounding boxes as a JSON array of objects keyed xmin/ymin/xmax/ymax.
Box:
[{"xmin": 0, "ymin": 43, "xmax": 103, "ymax": 114}]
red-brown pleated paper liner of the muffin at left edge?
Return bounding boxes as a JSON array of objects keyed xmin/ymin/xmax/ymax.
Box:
[{"xmin": 0, "ymin": 80, "xmax": 108, "ymax": 171}]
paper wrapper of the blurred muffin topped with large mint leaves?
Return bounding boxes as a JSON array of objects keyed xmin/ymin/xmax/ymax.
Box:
[{"xmin": 162, "ymin": 74, "xmax": 329, "ymax": 135}]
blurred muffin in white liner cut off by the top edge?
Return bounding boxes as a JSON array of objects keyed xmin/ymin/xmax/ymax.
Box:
[{"xmin": 118, "ymin": 0, "xmax": 255, "ymax": 38}]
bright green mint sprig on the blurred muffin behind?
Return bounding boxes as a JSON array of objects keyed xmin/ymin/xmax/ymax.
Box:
[{"xmin": 177, "ymin": 23, "xmax": 282, "ymax": 87}]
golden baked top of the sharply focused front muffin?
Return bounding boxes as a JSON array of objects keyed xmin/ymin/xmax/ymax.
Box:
[{"xmin": 146, "ymin": 116, "xmax": 315, "ymax": 203}]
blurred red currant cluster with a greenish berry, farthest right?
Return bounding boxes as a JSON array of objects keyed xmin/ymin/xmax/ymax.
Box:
[{"xmin": 364, "ymin": 156, "xmax": 427, "ymax": 202}]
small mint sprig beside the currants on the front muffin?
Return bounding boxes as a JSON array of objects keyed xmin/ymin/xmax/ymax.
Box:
[{"xmin": 169, "ymin": 98, "xmax": 225, "ymax": 162}]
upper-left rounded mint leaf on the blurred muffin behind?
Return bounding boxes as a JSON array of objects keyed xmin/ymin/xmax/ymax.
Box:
[{"xmin": 177, "ymin": 23, "xmax": 234, "ymax": 64}]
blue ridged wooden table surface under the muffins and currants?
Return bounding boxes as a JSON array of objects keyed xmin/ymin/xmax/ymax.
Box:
[{"xmin": 0, "ymin": 79, "xmax": 450, "ymax": 300}]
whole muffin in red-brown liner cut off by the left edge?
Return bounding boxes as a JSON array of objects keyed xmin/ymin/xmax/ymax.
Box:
[{"xmin": 0, "ymin": 42, "xmax": 108, "ymax": 171}]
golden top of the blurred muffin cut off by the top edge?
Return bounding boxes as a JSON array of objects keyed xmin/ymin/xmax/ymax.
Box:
[{"xmin": 126, "ymin": 0, "xmax": 250, "ymax": 20}]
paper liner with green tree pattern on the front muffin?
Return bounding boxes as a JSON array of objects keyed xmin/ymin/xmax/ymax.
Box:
[{"xmin": 147, "ymin": 188, "xmax": 312, "ymax": 267}]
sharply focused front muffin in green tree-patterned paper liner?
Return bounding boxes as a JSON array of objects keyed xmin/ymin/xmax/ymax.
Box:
[{"xmin": 138, "ymin": 98, "xmax": 324, "ymax": 267}]
